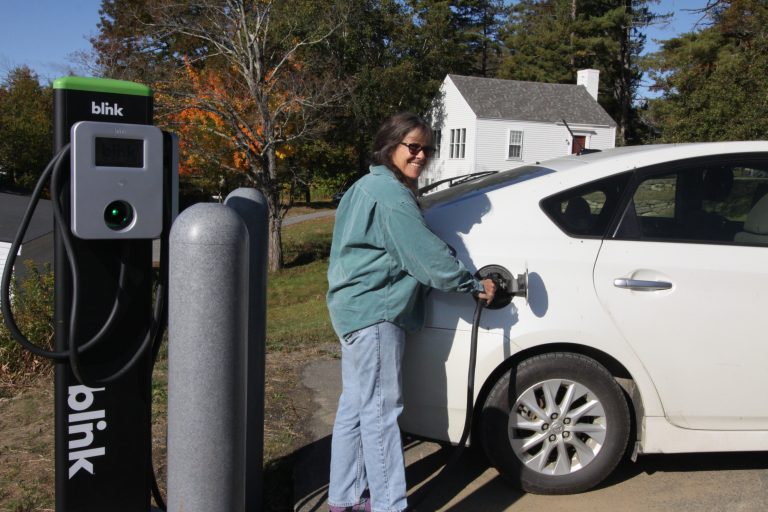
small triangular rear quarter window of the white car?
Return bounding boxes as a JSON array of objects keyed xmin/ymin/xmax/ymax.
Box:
[{"xmin": 541, "ymin": 173, "xmax": 631, "ymax": 237}]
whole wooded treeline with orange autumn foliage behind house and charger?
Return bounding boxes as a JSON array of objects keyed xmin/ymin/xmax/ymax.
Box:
[{"xmin": 0, "ymin": 0, "xmax": 768, "ymax": 268}]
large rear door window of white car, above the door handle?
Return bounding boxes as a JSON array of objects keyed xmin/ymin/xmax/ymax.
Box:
[{"xmin": 616, "ymin": 162, "xmax": 768, "ymax": 245}]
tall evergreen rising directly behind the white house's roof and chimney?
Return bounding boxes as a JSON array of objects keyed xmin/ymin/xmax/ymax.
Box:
[{"xmin": 499, "ymin": 0, "xmax": 660, "ymax": 145}]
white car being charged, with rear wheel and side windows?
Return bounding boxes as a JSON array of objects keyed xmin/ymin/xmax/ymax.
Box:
[{"xmin": 400, "ymin": 142, "xmax": 768, "ymax": 494}]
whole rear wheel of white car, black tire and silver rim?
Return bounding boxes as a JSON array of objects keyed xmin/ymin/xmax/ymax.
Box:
[{"xmin": 479, "ymin": 352, "xmax": 630, "ymax": 494}]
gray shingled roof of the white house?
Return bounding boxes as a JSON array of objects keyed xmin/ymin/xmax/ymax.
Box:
[{"xmin": 448, "ymin": 75, "xmax": 616, "ymax": 126}]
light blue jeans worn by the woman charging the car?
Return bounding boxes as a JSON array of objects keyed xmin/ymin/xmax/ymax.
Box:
[{"xmin": 328, "ymin": 322, "xmax": 408, "ymax": 512}]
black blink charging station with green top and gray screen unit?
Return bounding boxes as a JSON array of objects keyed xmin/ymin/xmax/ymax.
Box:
[{"xmin": 51, "ymin": 77, "xmax": 177, "ymax": 512}]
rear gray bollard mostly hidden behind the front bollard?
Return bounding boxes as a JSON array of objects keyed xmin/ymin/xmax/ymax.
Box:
[{"xmin": 224, "ymin": 188, "xmax": 269, "ymax": 512}]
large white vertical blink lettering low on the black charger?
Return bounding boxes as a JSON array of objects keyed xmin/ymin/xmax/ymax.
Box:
[{"xmin": 67, "ymin": 386, "xmax": 107, "ymax": 479}]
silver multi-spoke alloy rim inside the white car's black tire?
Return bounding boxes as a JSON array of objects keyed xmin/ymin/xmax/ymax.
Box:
[{"xmin": 507, "ymin": 379, "xmax": 608, "ymax": 476}]
